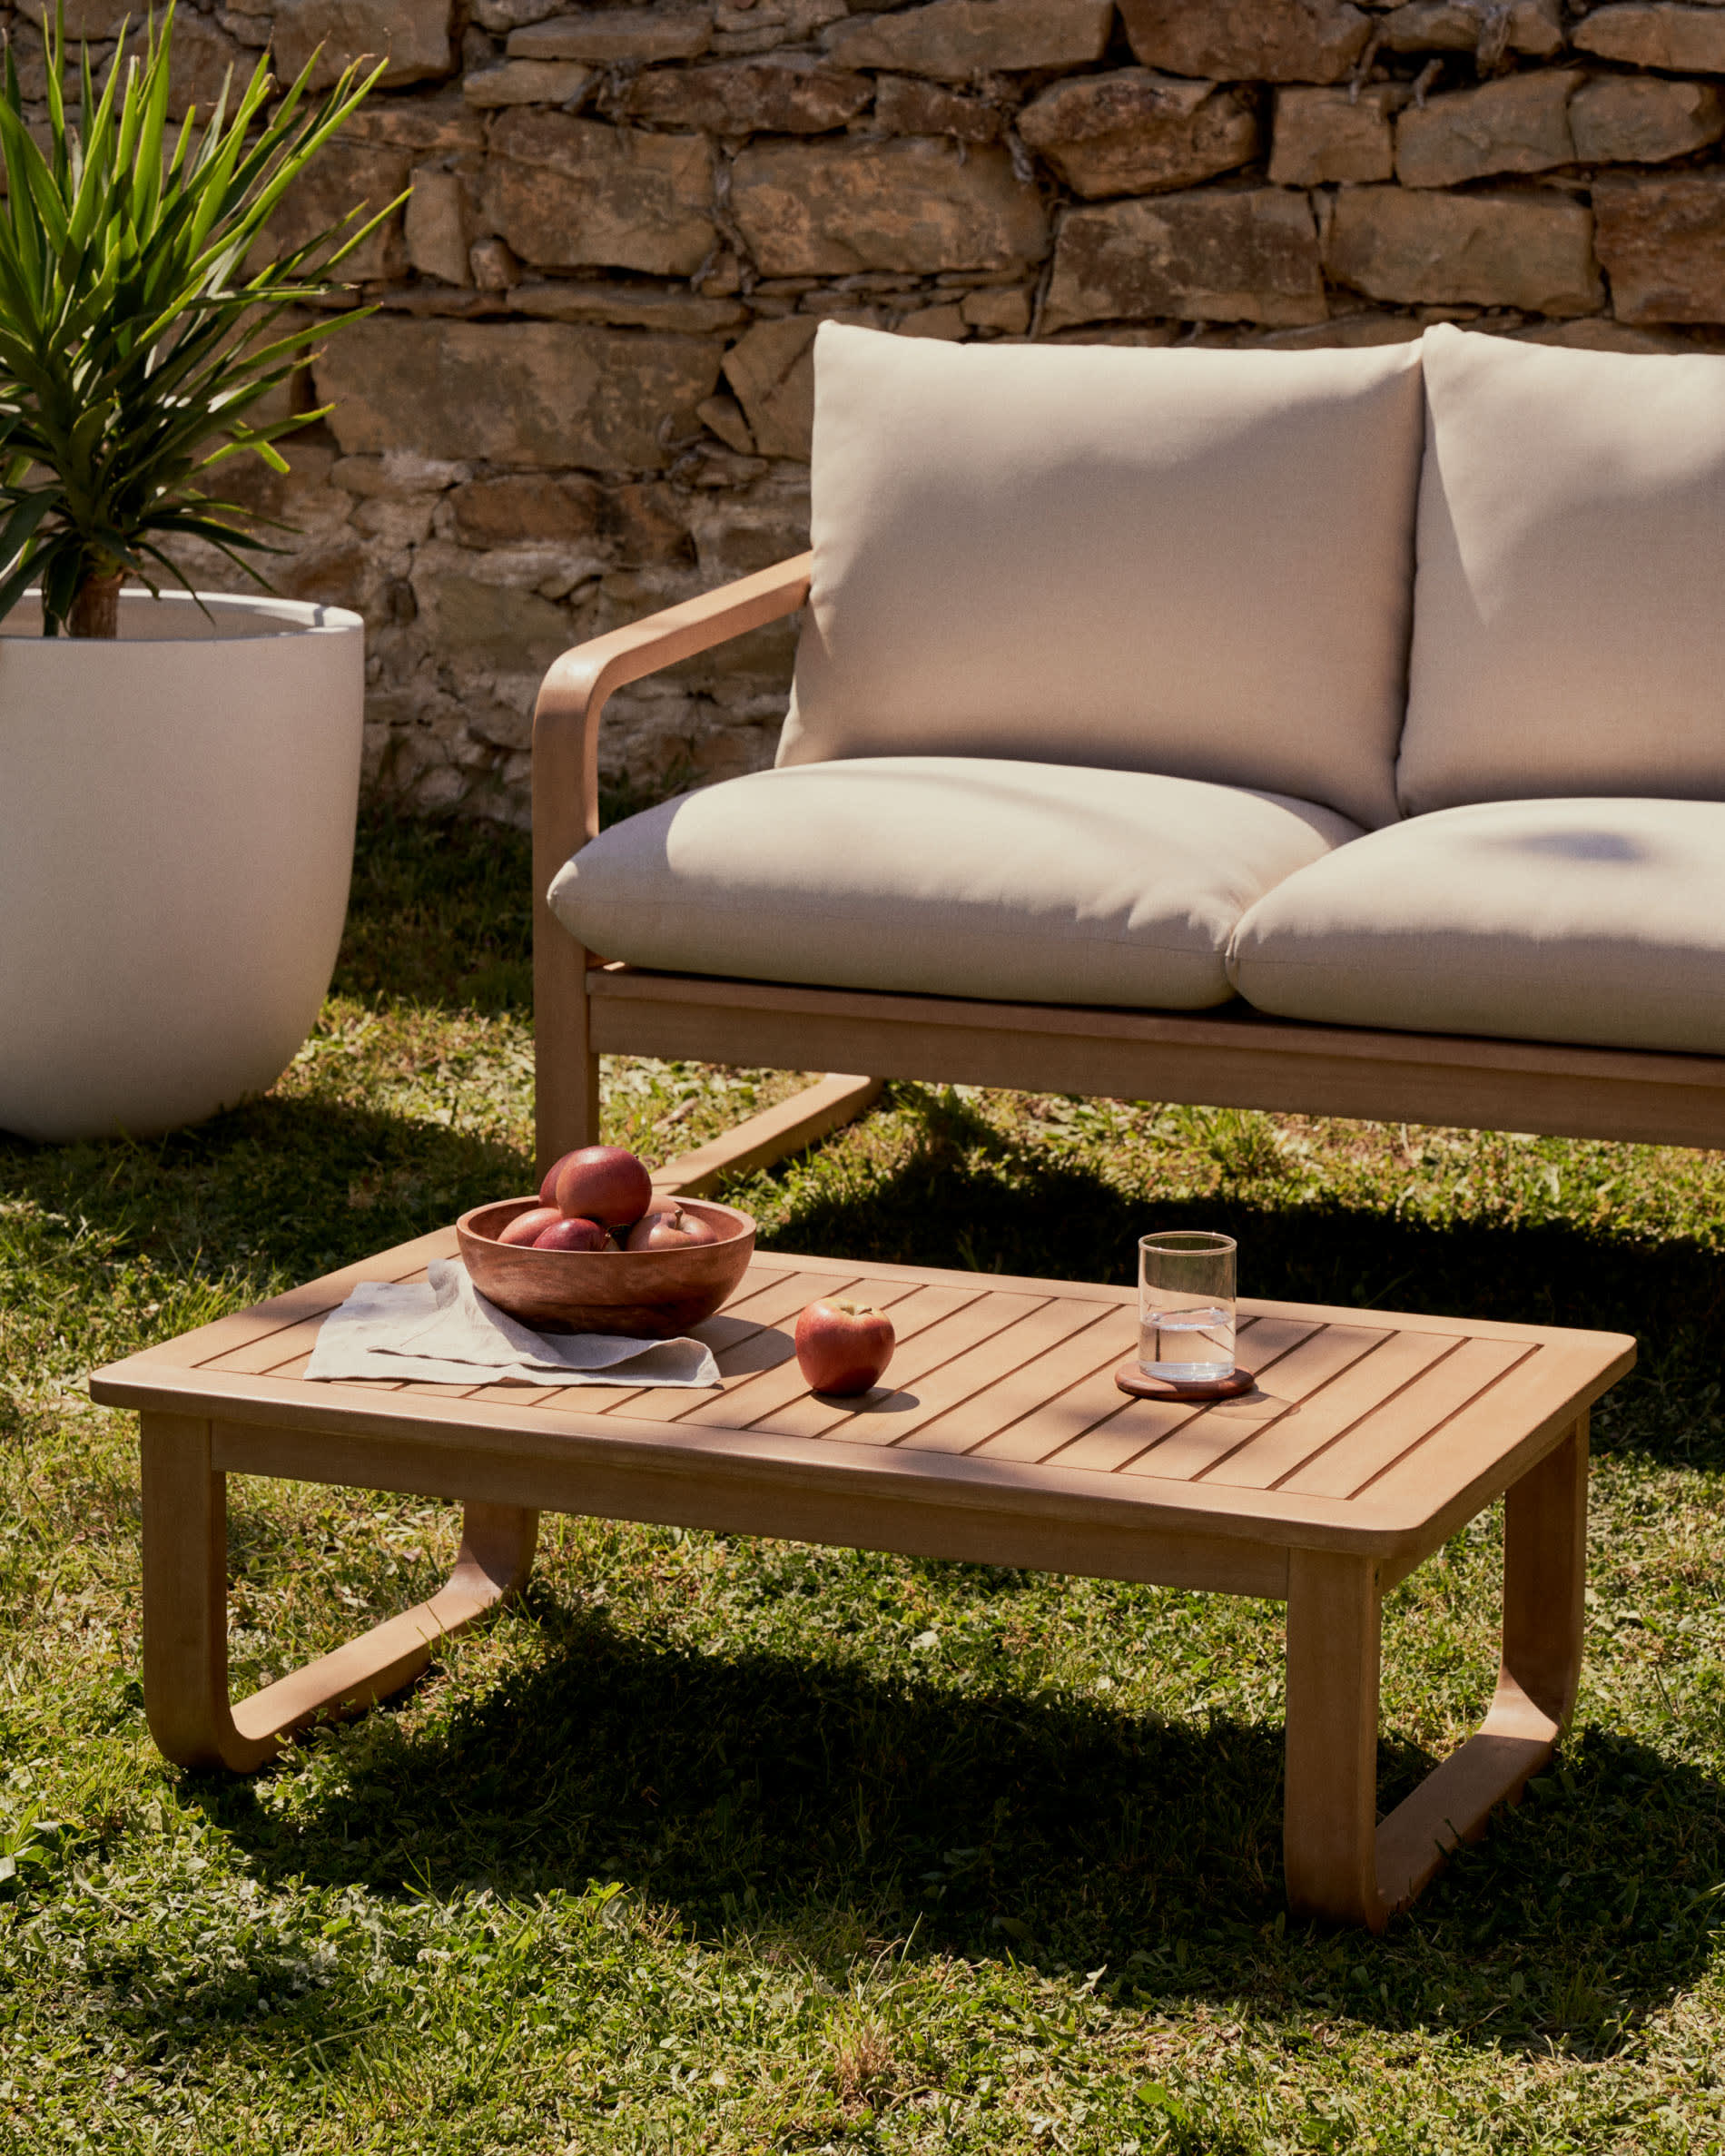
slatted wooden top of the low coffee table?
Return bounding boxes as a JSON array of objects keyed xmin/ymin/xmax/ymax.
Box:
[{"xmin": 91, "ymin": 1229, "xmax": 1634, "ymax": 1557}]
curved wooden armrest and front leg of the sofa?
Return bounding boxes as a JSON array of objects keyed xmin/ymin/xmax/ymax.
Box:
[{"xmin": 533, "ymin": 554, "xmax": 830, "ymax": 1168}]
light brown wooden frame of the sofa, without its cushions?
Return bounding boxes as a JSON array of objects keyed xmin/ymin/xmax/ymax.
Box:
[{"xmin": 533, "ymin": 554, "xmax": 1725, "ymax": 1190}]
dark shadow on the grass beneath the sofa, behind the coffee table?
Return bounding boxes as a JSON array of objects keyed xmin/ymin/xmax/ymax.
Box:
[{"xmin": 761, "ymin": 1087, "xmax": 1725, "ymax": 1468}]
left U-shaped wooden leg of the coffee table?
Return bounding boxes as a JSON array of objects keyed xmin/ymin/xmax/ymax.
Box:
[{"xmin": 143, "ymin": 1413, "xmax": 539, "ymax": 1775}]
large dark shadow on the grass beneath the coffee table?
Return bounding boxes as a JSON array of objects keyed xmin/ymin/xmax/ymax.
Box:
[{"xmin": 185, "ymin": 1604, "xmax": 1725, "ymax": 2051}]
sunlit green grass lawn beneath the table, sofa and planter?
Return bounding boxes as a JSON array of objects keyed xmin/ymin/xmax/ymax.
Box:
[{"xmin": 0, "ymin": 826, "xmax": 1725, "ymax": 2156}]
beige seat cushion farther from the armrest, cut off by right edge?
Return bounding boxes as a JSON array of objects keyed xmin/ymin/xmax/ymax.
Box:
[{"xmin": 1229, "ymin": 800, "xmax": 1725, "ymax": 1054}]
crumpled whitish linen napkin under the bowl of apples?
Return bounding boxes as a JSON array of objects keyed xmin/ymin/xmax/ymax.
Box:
[{"xmin": 306, "ymin": 1257, "xmax": 718, "ymax": 1384}]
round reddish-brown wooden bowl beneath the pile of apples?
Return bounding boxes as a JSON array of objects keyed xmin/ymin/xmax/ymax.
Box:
[{"xmin": 455, "ymin": 1195, "xmax": 754, "ymax": 1341}]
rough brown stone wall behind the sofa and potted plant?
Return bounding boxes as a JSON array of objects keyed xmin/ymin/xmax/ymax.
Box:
[{"xmin": 13, "ymin": 0, "xmax": 1725, "ymax": 822}]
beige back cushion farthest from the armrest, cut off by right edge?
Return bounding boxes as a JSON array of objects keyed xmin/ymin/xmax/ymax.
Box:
[{"xmin": 1397, "ymin": 326, "xmax": 1725, "ymax": 815}]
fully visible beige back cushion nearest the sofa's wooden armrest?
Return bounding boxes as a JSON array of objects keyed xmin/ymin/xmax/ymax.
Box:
[{"xmin": 778, "ymin": 323, "xmax": 1424, "ymax": 826}]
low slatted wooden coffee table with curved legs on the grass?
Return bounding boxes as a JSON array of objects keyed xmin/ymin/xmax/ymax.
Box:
[{"xmin": 91, "ymin": 1231, "xmax": 1634, "ymax": 1930}]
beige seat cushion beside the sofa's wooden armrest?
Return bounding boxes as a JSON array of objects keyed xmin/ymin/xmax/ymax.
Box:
[{"xmin": 550, "ymin": 757, "xmax": 1356, "ymax": 1009}]
